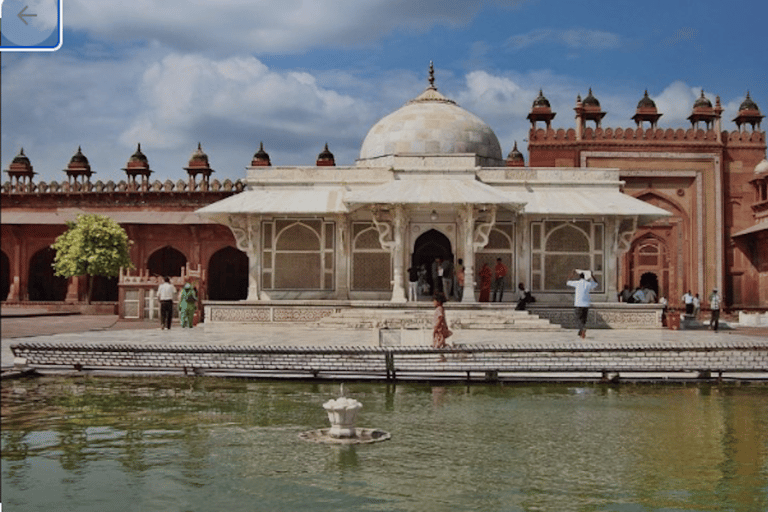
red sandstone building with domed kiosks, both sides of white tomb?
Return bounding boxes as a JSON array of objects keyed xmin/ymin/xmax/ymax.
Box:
[{"xmin": 0, "ymin": 90, "xmax": 768, "ymax": 309}]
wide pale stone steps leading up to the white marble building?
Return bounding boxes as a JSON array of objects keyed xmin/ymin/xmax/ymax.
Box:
[{"xmin": 315, "ymin": 305, "xmax": 561, "ymax": 331}]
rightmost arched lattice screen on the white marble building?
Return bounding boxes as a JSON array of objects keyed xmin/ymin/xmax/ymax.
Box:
[{"xmin": 531, "ymin": 220, "xmax": 605, "ymax": 292}]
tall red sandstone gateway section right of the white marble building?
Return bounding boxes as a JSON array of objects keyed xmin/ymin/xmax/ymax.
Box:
[{"xmin": 528, "ymin": 89, "xmax": 768, "ymax": 309}]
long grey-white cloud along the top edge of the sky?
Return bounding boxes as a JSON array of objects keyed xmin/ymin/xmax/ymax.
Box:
[{"xmin": 67, "ymin": 0, "xmax": 522, "ymax": 55}]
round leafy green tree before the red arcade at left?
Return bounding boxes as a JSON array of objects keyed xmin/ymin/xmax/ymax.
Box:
[{"xmin": 51, "ymin": 213, "xmax": 133, "ymax": 304}]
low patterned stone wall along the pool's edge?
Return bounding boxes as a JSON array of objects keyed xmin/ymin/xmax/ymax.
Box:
[{"xmin": 11, "ymin": 340, "xmax": 768, "ymax": 379}]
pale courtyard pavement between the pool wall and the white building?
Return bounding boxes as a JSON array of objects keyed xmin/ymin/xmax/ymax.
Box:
[{"xmin": 0, "ymin": 311, "xmax": 768, "ymax": 368}]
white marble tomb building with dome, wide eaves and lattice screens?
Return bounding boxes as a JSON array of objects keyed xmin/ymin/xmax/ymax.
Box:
[{"xmin": 198, "ymin": 81, "xmax": 668, "ymax": 304}]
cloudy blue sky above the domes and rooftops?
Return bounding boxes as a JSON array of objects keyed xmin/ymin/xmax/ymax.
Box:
[{"xmin": 0, "ymin": 0, "xmax": 768, "ymax": 182}]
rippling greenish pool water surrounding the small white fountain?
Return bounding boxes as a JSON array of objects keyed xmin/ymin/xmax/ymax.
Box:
[{"xmin": 2, "ymin": 377, "xmax": 768, "ymax": 512}]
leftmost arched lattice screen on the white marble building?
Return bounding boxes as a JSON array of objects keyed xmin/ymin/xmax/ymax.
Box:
[{"xmin": 262, "ymin": 219, "xmax": 334, "ymax": 290}]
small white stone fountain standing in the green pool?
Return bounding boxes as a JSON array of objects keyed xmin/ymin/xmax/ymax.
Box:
[{"xmin": 299, "ymin": 384, "xmax": 390, "ymax": 444}]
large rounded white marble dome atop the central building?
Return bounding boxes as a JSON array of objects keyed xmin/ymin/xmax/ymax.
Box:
[{"xmin": 360, "ymin": 87, "xmax": 502, "ymax": 161}]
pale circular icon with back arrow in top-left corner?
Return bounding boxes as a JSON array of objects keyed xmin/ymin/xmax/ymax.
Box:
[{"xmin": 2, "ymin": 0, "xmax": 59, "ymax": 46}]
